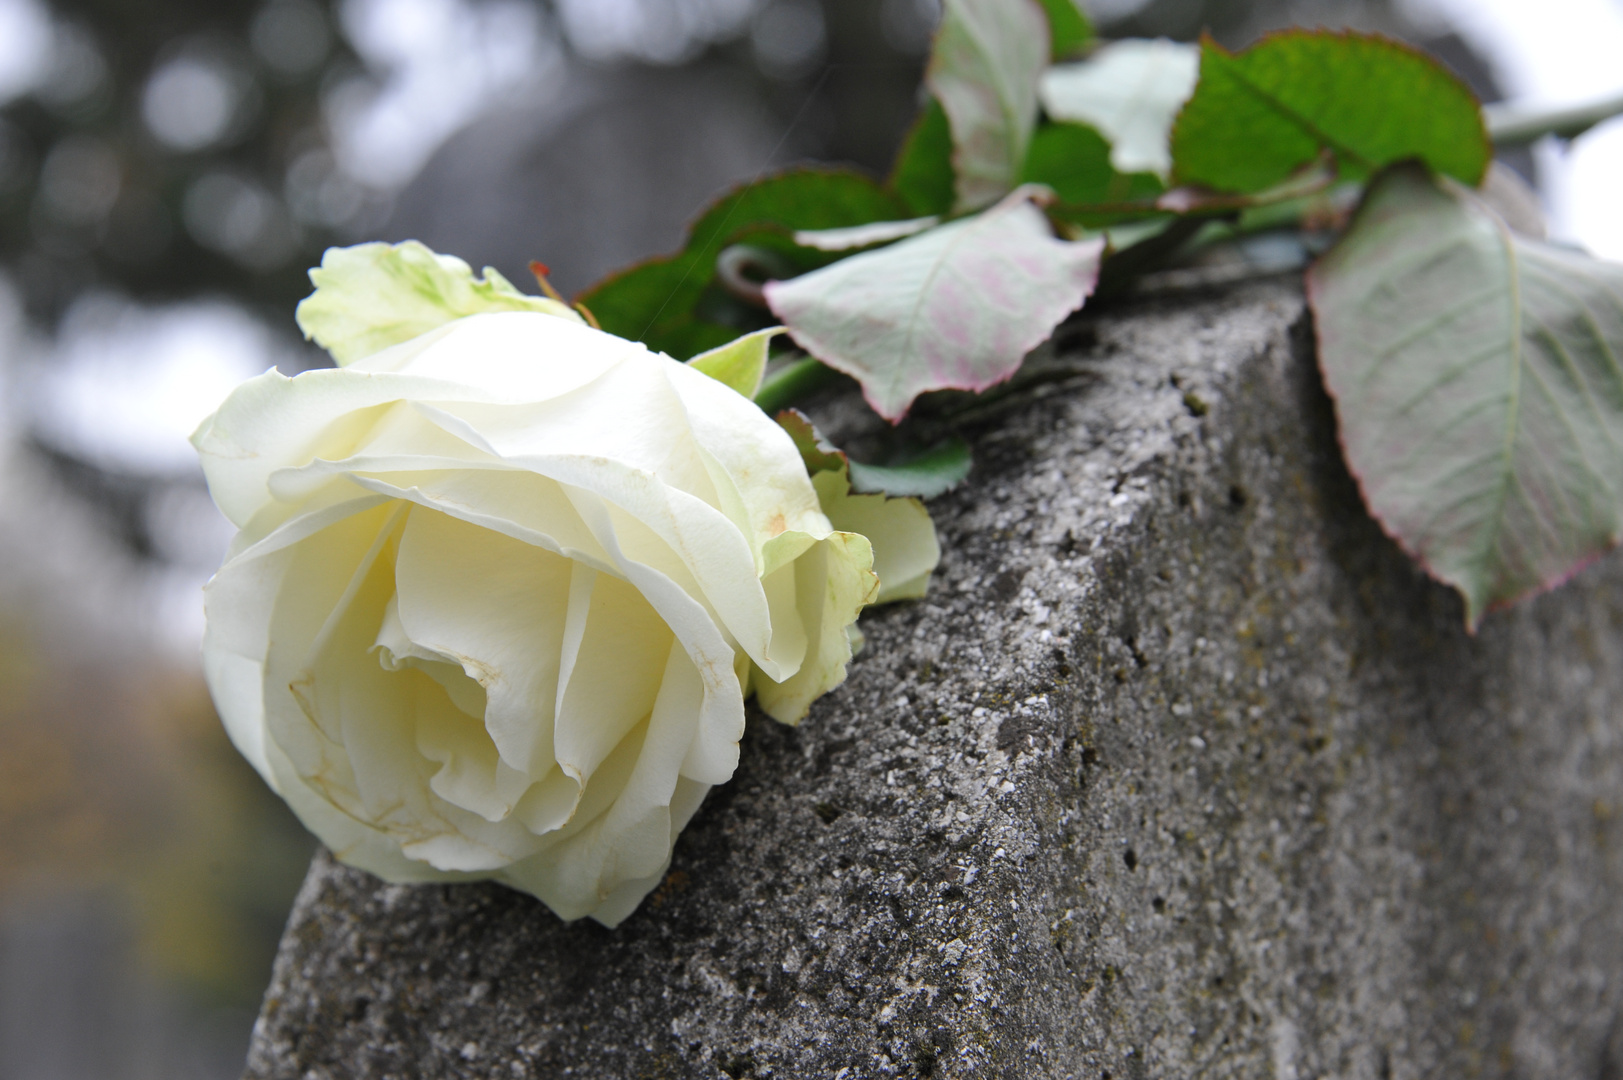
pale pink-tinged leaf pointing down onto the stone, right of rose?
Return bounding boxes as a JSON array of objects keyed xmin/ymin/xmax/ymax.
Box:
[{"xmin": 766, "ymin": 188, "xmax": 1104, "ymax": 421}]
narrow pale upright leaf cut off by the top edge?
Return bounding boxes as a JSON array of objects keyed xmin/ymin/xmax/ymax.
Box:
[{"xmin": 923, "ymin": 0, "xmax": 1048, "ymax": 213}]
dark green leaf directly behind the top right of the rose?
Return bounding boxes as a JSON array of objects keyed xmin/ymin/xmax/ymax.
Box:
[{"xmin": 579, "ymin": 169, "xmax": 907, "ymax": 359}]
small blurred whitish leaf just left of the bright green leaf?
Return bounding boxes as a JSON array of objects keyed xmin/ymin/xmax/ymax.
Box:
[{"xmin": 1039, "ymin": 37, "xmax": 1201, "ymax": 177}]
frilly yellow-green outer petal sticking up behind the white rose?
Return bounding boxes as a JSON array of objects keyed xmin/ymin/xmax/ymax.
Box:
[{"xmin": 297, "ymin": 240, "xmax": 581, "ymax": 367}]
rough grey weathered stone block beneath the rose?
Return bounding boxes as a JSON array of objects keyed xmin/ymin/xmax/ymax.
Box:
[{"xmin": 248, "ymin": 284, "xmax": 1623, "ymax": 1080}]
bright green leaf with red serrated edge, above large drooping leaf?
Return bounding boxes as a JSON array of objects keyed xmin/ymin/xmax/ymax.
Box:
[{"xmin": 1172, "ymin": 31, "xmax": 1493, "ymax": 192}]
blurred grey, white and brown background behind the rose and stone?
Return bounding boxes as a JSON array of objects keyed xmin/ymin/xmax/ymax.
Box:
[{"xmin": 0, "ymin": 0, "xmax": 1623, "ymax": 1080}]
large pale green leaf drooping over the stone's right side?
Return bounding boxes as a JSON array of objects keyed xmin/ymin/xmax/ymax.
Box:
[{"xmin": 1308, "ymin": 166, "xmax": 1623, "ymax": 627}]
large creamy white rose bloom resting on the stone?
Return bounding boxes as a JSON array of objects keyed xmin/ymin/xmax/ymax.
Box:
[{"xmin": 193, "ymin": 290, "xmax": 889, "ymax": 926}]
